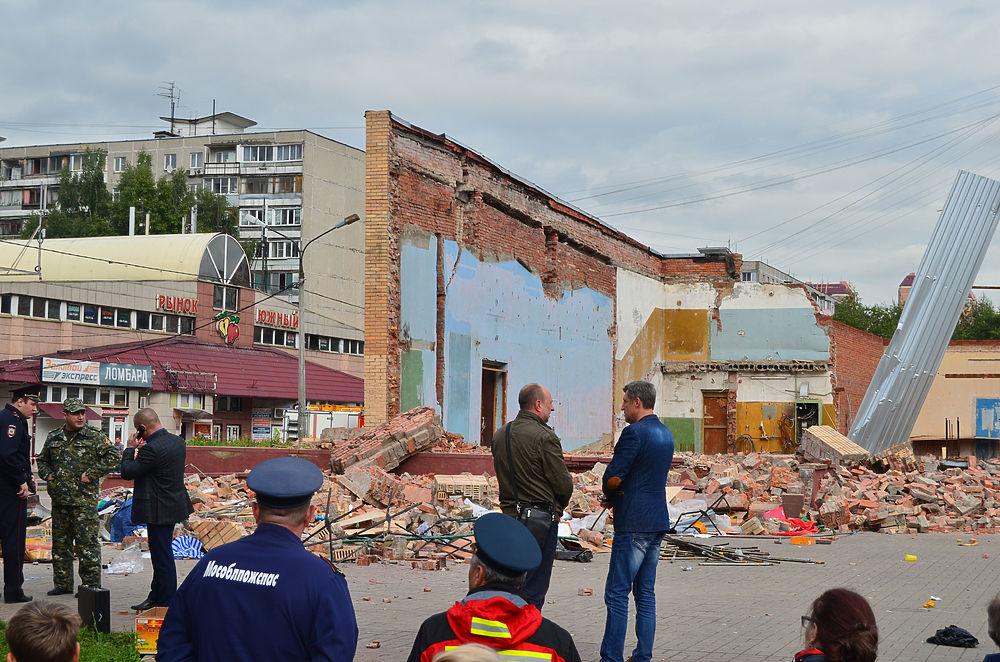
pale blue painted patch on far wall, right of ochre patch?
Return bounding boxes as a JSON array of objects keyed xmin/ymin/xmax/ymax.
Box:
[{"xmin": 709, "ymin": 308, "xmax": 830, "ymax": 361}]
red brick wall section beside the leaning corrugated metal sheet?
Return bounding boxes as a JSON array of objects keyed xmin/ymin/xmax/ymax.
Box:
[{"xmin": 818, "ymin": 316, "xmax": 885, "ymax": 434}]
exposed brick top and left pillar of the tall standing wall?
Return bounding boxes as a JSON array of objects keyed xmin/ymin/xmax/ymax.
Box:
[{"xmin": 365, "ymin": 111, "xmax": 740, "ymax": 424}]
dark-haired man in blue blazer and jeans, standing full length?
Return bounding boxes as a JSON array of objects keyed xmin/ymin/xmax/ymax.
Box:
[{"xmin": 601, "ymin": 381, "xmax": 674, "ymax": 662}]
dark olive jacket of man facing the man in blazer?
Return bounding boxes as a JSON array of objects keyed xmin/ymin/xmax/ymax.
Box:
[{"xmin": 493, "ymin": 411, "xmax": 573, "ymax": 515}]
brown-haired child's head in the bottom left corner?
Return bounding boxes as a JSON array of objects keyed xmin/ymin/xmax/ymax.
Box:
[{"xmin": 7, "ymin": 602, "xmax": 80, "ymax": 662}]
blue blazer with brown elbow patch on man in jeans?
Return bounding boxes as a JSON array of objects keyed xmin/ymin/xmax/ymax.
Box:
[{"xmin": 603, "ymin": 414, "xmax": 674, "ymax": 533}]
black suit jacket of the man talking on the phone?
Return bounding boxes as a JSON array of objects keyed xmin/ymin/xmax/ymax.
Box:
[{"xmin": 121, "ymin": 428, "xmax": 194, "ymax": 524}]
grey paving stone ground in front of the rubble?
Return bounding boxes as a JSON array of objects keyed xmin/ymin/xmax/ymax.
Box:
[{"xmin": 0, "ymin": 533, "xmax": 1000, "ymax": 662}]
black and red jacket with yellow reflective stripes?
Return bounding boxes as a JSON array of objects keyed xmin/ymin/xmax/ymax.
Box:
[{"xmin": 407, "ymin": 586, "xmax": 580, "ymax": 662}]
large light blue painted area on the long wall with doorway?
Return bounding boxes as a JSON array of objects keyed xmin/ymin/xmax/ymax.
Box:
[{"xmin": 401, "ymin": 237, "xmax": 613, "ymax": 450}]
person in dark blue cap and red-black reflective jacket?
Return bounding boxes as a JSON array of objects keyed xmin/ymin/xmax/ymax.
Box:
[{"xmin": 407, "ymin": 513, "xmax": 580, "ymax": 662}]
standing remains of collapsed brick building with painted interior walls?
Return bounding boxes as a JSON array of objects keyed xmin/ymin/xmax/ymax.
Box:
[{"xmin": 365, "ymin": 111, "xmax": 882, "ymax": 453}]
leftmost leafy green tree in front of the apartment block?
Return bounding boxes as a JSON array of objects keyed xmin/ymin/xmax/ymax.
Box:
[{"xmin": 22, "ymin": 150, "xmax": 114, "ymax": 238}]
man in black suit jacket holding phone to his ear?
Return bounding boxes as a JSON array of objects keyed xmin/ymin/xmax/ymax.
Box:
[{"xmin": 121, "ymin": 409, "xmax": 194, "ymax": 611}]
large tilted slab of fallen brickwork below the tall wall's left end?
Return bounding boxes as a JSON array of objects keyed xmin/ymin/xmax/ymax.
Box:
[{"xmin": 330, "ymin": 407, "xmax": 444, "ymax": 473}]
